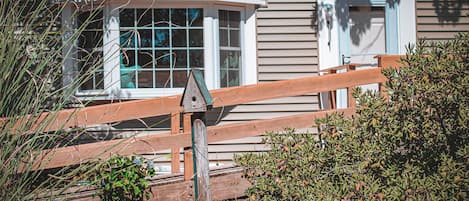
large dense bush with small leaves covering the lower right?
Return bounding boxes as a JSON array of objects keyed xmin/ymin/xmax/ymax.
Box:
[{"xmin": 237, "ymin": 33, "xmax": 469, "ymax": 200}]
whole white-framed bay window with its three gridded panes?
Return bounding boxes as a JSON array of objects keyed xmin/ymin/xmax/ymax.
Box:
[{"xmin": 64, "ymin": 3, "xmax": 257, "ymax": 99}]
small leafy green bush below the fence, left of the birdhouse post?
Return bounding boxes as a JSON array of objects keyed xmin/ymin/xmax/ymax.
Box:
[{"xmin": 93, "ymin": 156, "xmax": 155, "ymax": 201}]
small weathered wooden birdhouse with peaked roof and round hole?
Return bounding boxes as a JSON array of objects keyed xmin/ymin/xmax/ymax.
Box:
[{"xmin": 181, "ymin": 69, "xmax": 213, "ymax": 113}]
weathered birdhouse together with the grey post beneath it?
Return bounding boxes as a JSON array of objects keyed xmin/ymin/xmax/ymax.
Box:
[{"xmin": 181, "ymin": 69, "xmax": 213, "ymax": 201}]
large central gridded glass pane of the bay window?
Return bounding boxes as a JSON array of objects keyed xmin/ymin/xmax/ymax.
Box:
[{"xmin": 119, "ymin": 8, "xmax": 204, "ymax": 89}]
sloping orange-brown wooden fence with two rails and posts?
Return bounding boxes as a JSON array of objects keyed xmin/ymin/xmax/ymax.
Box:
[{"xmin": 0, "ymin": 55, "xmax": 401, "ymax": 179}]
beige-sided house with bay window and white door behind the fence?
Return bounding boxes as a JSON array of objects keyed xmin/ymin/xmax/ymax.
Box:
[{"xmin": 58, "ymin": 0, "xmax": 469, "ymax": 170}]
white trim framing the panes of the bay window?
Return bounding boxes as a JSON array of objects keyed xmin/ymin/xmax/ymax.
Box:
[{"xmin": 64, "ymin": 1, "xmax": 257, "ymax": 100}]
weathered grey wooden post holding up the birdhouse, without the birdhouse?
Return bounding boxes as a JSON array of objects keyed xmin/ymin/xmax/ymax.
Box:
[{"xmin": 192, "ymin": 113, "xmax": 211, "ymax": 201}]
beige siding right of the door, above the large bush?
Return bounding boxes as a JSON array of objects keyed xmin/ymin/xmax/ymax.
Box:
[{"xmin": 416, "ymin": 0, "xmax": 469, "ymax": 41}]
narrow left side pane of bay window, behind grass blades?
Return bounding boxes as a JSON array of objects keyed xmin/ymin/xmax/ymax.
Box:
[{"xmin": 77, "ymin": 11, "xmax": 104, "ymax": 90}]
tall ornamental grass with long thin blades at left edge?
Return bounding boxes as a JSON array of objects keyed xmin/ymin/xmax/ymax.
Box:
[{"xmin": 0, "ymin": 0, "xmax": 104, "ymax": 200}]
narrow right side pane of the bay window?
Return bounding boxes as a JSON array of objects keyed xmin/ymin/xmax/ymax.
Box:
[{"xmin": 218, "ymin": 10, "xmax": 241, "ymax": 87}]
